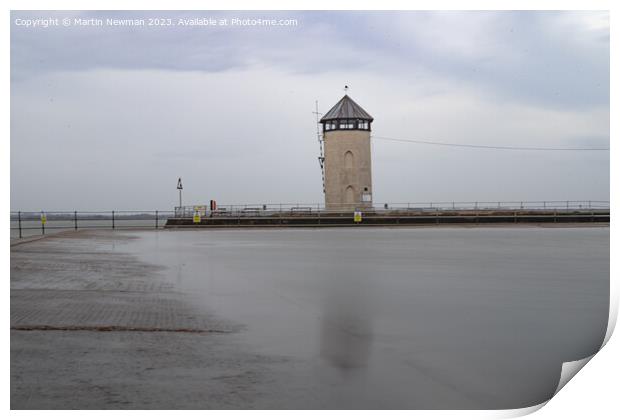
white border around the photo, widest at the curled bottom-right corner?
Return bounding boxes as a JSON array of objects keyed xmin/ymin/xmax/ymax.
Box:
[{"xmin": 0, "ymin": 0, "xmax": 620, "ymax": 419}]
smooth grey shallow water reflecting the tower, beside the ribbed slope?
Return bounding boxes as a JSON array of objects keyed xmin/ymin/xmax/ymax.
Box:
[{"xmin": 116, "ymin": 227, "xmax": 609, "ymax": 409}]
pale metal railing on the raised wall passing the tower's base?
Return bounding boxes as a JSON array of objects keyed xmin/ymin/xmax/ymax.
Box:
[{"xmin": 174, "ymin": 200, "xmax": 609, "ymax": 218}]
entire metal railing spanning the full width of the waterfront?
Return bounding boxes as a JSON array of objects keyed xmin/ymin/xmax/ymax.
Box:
[{"xmin": 11, "ymin": 200, "xmax": 609, "ymax": 238}]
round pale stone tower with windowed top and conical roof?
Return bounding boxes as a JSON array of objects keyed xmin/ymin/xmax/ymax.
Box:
[{"xmin": 321, "ymin": 95, "xmax": 373, "ymax": 211}]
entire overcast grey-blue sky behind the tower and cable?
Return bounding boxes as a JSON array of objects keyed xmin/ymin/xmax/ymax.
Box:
[{"xmin": 11, "ymin": 11, "xmax": 610, "ymax": 210}]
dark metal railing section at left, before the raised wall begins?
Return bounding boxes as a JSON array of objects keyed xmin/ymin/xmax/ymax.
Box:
[{"xmin": 11, "ymin": 210, "xmax": 174, "ymax": 239}]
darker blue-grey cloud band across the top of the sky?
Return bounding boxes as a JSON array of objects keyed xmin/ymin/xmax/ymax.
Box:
[{"xmin": 11, "ymin": 11, "xmax": 609, "ymax": 108}]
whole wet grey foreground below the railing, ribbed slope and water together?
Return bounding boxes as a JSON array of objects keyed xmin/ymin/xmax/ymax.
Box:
[{"xmin": 11, "ymin": 226, "xmax": 609, "ymax": 409}]
